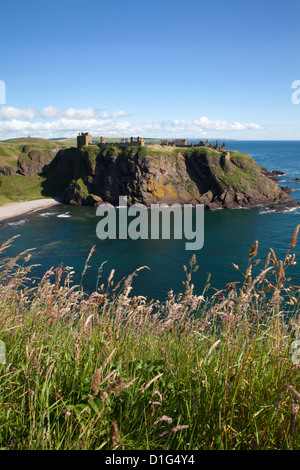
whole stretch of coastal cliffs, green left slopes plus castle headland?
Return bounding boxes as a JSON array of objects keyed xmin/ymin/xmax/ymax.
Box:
[{"xmin": 0, "ymin": 138, "xmax": 292, "ymax": 209}]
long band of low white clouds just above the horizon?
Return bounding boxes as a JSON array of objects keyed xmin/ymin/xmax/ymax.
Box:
[{"xmin": 0, "ymin": 106, "xmax": 263, "ymax": 139}]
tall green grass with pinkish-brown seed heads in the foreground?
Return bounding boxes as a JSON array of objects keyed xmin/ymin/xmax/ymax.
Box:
[{"xmin": 0, "ymin": 227, "xmax": 300, "ymax": 450}]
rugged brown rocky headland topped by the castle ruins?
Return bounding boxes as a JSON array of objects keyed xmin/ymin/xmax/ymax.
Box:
[{"xmin": 45, "ymin": 146, "xmax": 292, "ymax": 209}]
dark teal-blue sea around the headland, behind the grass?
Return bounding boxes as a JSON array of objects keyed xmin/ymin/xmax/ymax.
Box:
[{"xmin": 0, "ymin": 140, "xmax": 300, "ymax": 301}]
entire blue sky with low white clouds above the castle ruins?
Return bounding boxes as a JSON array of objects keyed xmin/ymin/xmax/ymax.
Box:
[{"xmin": 0, "ymin": 0, "xmax": 300, "ymax": 140}]
